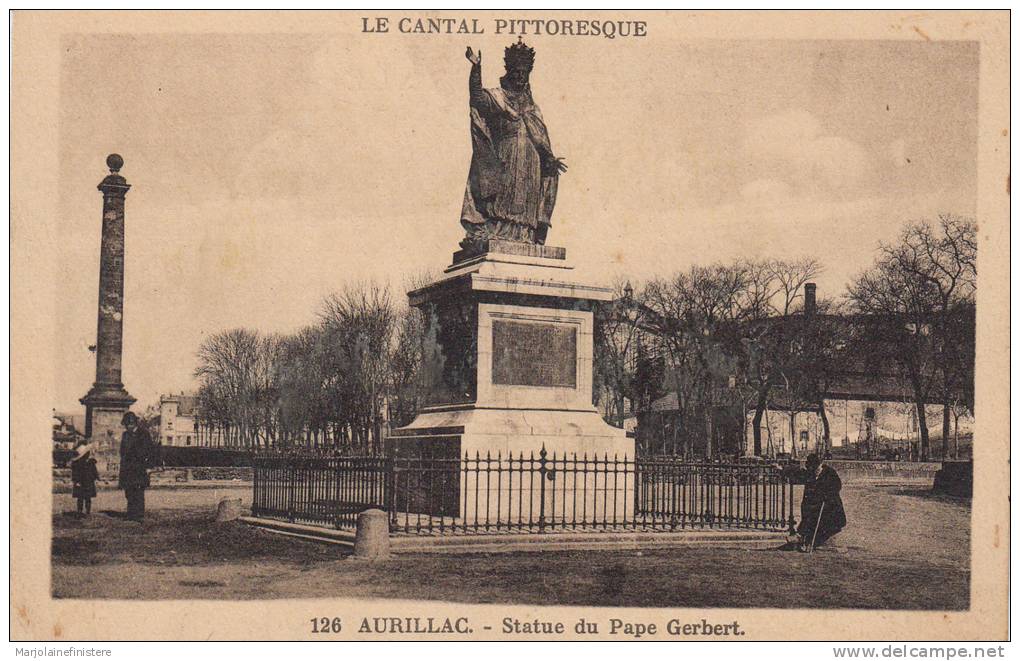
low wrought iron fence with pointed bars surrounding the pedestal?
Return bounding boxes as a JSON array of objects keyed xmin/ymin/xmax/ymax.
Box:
[{"xmin": 252, "ymin": 449, "xmax": 795, "ymax": 535}]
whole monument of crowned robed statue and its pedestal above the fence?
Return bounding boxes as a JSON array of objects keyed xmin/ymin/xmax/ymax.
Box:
[{"xmin": 389, "ymin": 42, "xmax": 634, "ymax": 516}]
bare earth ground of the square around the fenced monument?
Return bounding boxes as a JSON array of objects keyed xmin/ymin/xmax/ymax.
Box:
[{"xmin": 52, "ymin": 484, "xmax": 970, "ymax": 610}]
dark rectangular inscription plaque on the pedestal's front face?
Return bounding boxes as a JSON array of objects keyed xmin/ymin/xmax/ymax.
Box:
[{"xmin": 493, "ymin": 320, "xmax": 577, "ymax": 388}]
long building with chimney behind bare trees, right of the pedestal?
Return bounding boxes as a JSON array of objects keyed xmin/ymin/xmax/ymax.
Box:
[{"xmin": 596, "ymin": 283, "xmax": 974, "ymax": 460}]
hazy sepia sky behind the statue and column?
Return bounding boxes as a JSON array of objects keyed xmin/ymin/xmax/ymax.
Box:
[{"xmin": 53, "ymin": 33, "xmax": 979, "ymax": 411}]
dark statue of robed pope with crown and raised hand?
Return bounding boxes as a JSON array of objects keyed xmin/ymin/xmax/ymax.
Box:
[{"xmin": 460, "ymin": 38, "xmax": 567, "ymax": 248}]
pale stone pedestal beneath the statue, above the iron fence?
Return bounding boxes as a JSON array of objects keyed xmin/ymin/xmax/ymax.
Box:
[{"xmin": 388, "ymin": 241, "xmax": 634, "ymax": 516}]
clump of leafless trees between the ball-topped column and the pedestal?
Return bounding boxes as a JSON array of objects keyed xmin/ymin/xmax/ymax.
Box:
[{"xmin": 195, "ymin": 283, "xmax": 425, "ymax": 452}]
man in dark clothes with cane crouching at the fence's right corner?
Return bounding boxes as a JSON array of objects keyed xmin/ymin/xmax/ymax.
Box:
[{"xmin": 786, "ymin": 454, "xmax": 847, "ymax": 553}]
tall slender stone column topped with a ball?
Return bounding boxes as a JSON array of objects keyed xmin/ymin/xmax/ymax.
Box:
[{"xmin": 81, "ymin": 154, "xmax": 135, "ymax": 471}]
